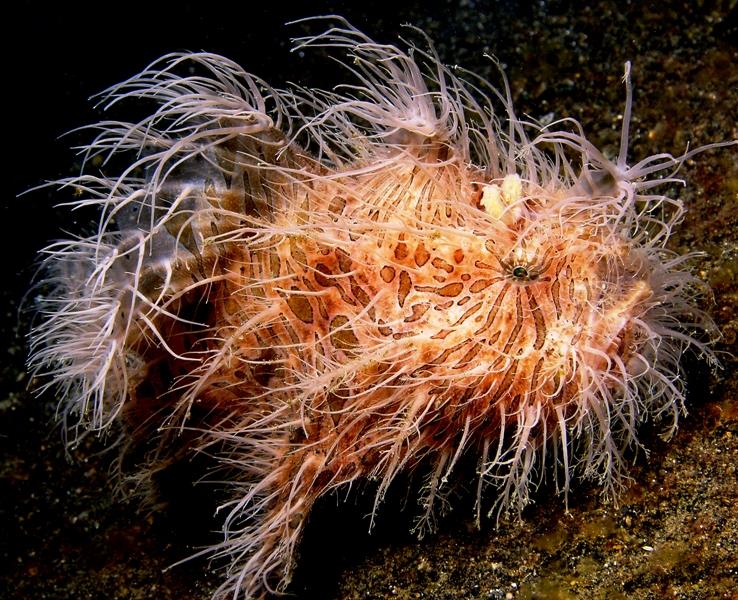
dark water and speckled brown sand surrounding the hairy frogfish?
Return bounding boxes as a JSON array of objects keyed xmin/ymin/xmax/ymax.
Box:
[{"xmin": 0, "ymin": 0, "xmax": 738, "ymax": 600}]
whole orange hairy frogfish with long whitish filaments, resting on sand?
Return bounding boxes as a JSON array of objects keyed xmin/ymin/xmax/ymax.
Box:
[{"xmin": 25, "ymin": 17, "xmax": 737, "ymax": 598}]
